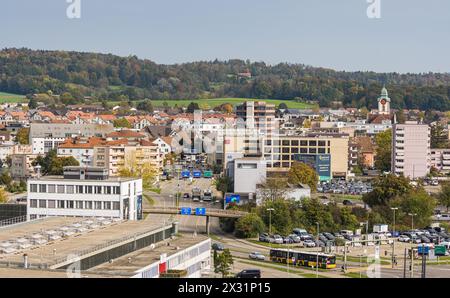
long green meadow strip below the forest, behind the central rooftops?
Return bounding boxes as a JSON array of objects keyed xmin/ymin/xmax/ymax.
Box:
[{"xmin": 108, "ymin": 98, "xmax": 314, "ymax": 109}]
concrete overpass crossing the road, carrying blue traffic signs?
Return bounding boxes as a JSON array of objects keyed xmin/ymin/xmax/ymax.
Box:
[{"xmin": 143, "ymin": 207, "xmax": 248, "ymax": 235}]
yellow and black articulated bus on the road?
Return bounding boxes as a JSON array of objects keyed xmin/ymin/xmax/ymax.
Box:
[{"xmin": 270, "ymin": 249, "xmax": 336, "ymax": 269}]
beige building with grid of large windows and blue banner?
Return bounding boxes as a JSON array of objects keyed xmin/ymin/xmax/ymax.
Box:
[{"xmin": 263, "ymin": 133, "xmax": 349, "ymax": 180}]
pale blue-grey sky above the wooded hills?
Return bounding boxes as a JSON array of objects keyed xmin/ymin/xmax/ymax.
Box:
[{"xmin": 0, "ymin": 0, "xmax": 450, "ymax": 73}]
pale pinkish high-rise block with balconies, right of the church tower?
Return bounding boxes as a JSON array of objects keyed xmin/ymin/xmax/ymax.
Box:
[{"xmin": 392, "ymin": 121, "xmax": 431, "ymax": 179}]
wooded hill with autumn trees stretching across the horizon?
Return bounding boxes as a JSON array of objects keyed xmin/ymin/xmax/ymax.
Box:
[{"xmin": 0, "ymin": 49, "xmax": 450, "ymax": 110}]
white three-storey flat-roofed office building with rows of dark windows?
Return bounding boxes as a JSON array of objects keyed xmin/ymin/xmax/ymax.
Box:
[{"xmin": 27, "ymin": 167, "xmax": 142, "ymax": 220}]
